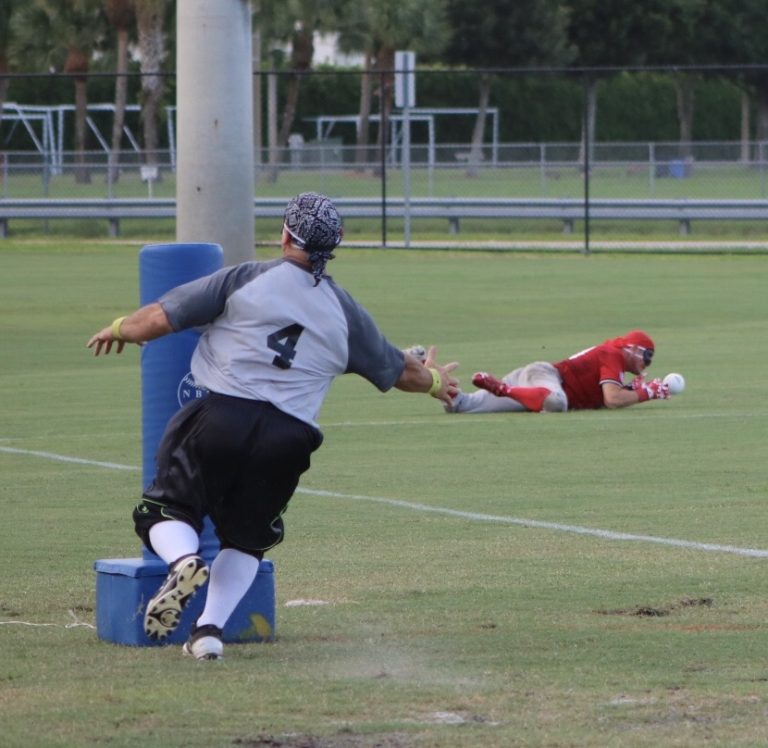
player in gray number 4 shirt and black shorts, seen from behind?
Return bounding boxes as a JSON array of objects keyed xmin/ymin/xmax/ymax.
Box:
[{"xmin": 87, "ymin": 192, "xmax": 458, "ymax": 659}]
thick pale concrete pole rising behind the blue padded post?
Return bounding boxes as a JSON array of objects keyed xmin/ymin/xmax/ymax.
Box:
[{"xmin": 176, "ymin": 0, "xmax": 254, "ymax": 265}]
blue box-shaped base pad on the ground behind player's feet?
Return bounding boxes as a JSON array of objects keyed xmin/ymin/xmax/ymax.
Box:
[{"xmin": 94, "ymin": 558, "xmax": 275, "ymax": 647}]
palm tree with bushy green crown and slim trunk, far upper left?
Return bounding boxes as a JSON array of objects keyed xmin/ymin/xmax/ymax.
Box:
[{"xmin": 12, "ymin": 0, "xmax": 106, "ymax": 182}]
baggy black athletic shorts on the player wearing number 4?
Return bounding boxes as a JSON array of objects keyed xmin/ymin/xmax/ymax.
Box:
[{"xmin": 133, "ymin": 393, "xmax": 323, "ymax": 555}]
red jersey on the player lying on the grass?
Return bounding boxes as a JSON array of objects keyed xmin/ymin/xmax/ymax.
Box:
[{"xmin": 553, "ymin": 343, "xmax": 624, "ymax": 410}]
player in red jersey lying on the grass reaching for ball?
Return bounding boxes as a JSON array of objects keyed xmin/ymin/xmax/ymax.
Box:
[{"xmin": 446, "ymin": 330, "xmax": 669, "ymax": 413}]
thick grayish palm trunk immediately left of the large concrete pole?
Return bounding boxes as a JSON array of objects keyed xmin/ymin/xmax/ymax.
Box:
[{"xmin": 136, "ymin": 0, "xmax": 171, "ymax": 172}]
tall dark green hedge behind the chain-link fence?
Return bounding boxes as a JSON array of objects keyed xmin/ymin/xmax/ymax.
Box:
[{"xmin": 0, "ymin": 69, "xmax": 752, "ymax": 149}]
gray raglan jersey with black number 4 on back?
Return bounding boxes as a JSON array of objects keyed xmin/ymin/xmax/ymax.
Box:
[{"xmin": 159, "ymin": 258, "xmax": 404, "ymax": 427}]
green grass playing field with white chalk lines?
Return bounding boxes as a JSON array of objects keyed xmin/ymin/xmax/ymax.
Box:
[{"xmin": 0, "ymin": 239, "xmax": 768, "ymax": 748}]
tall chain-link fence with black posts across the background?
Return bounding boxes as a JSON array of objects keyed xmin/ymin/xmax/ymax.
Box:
[{"xmin": 0, "ymin": 71, "xmax": 768, "ymax": 251}]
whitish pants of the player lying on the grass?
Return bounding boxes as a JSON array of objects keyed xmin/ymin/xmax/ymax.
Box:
[{"xmin": 449, "ymin": 361, "xmax": 568, "ymax": 413}]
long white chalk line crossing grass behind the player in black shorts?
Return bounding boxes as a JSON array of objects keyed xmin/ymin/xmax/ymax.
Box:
[{"xmin": 6, "ymin": 446, "xmax": 768, "ymax": 558}]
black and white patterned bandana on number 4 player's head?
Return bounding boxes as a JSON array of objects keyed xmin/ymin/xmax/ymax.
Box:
[{"xmin": 283, "ymin": 192, "xmax": 344, "ymax": 285}]
